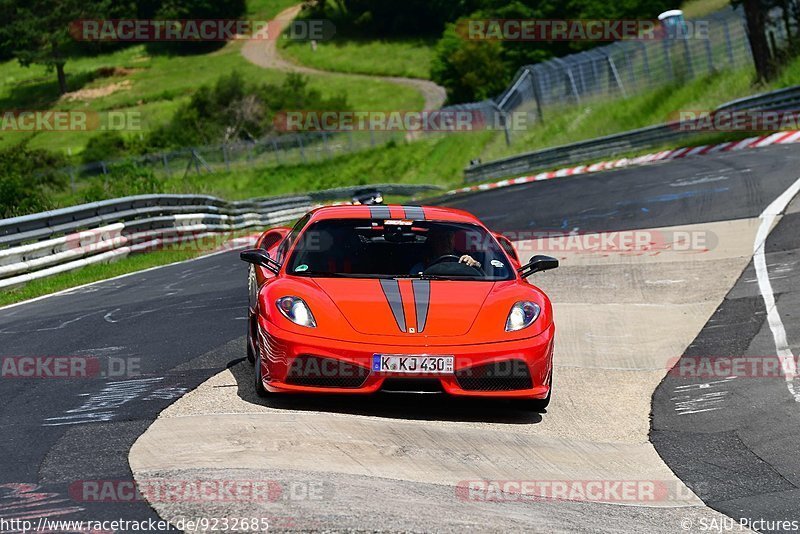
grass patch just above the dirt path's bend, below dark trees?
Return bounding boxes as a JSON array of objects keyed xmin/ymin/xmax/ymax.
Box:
[{"xmin": 280, "ymin": 36, "xmax": 436, "ymax": 79}]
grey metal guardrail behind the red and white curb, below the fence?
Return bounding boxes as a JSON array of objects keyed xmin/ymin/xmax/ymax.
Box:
[{"xmin": 464, "ymin": 86, "xmax": 800, "ymax": 182}]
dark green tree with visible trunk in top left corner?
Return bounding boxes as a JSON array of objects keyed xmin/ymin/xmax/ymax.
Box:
[{"xmin": 0, "ymin": 0, "xmax": 119, "ymax": 94}]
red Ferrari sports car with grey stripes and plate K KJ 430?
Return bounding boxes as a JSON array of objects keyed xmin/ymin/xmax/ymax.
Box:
[{"xmin": 241, "ymin": 206, "xmax": 558, "ymax": 410}]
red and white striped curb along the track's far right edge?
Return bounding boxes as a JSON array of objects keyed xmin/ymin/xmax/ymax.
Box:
[{"xmin": 446, "ymin": 130, "xmax": 800, "ymax": 195}]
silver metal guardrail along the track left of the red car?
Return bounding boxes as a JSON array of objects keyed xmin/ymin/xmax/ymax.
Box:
[{"xmin": 0, "ymin": 184, "xmax": 440, "ymax": 289}]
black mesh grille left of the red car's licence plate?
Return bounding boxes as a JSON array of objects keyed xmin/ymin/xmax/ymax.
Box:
[{"xmin": 286, "ymin": 354, "xmax": 370, "ymax": 388}]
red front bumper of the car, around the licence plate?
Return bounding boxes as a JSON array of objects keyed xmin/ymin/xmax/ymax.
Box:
[{"xmin": 257, "ymin": 319, "xmax": 555, "ymax": 399}]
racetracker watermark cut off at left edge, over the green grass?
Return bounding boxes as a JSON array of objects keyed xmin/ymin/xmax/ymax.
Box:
[{"xmin": 0, "ymin": 110, "xmax": 142, "ymax": 132}]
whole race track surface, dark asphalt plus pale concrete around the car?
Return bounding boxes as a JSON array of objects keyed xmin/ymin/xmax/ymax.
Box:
[{"xmin": 0, "ymin": 146, "xmax": 800, "ymax": 532}]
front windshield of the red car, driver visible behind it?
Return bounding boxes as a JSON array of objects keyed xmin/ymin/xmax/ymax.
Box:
[{"xmin": 287, "ymin": 219, "xmax": 514, "ymax": 281}]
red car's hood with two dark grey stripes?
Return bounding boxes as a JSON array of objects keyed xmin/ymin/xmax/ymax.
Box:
[{"xmin": 314, "ymin": 278, "xmax": 495, "ymax": 337}]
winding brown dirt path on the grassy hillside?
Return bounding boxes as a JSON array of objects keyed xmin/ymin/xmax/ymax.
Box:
[{"xmin": 242, "ymin": 4, "xmax": 446, "ymax": 109}]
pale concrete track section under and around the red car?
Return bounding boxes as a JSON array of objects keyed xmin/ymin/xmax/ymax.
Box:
[{"xmin": 130, "ymin": 219, "xmax": 758, "ymax": 532}]
